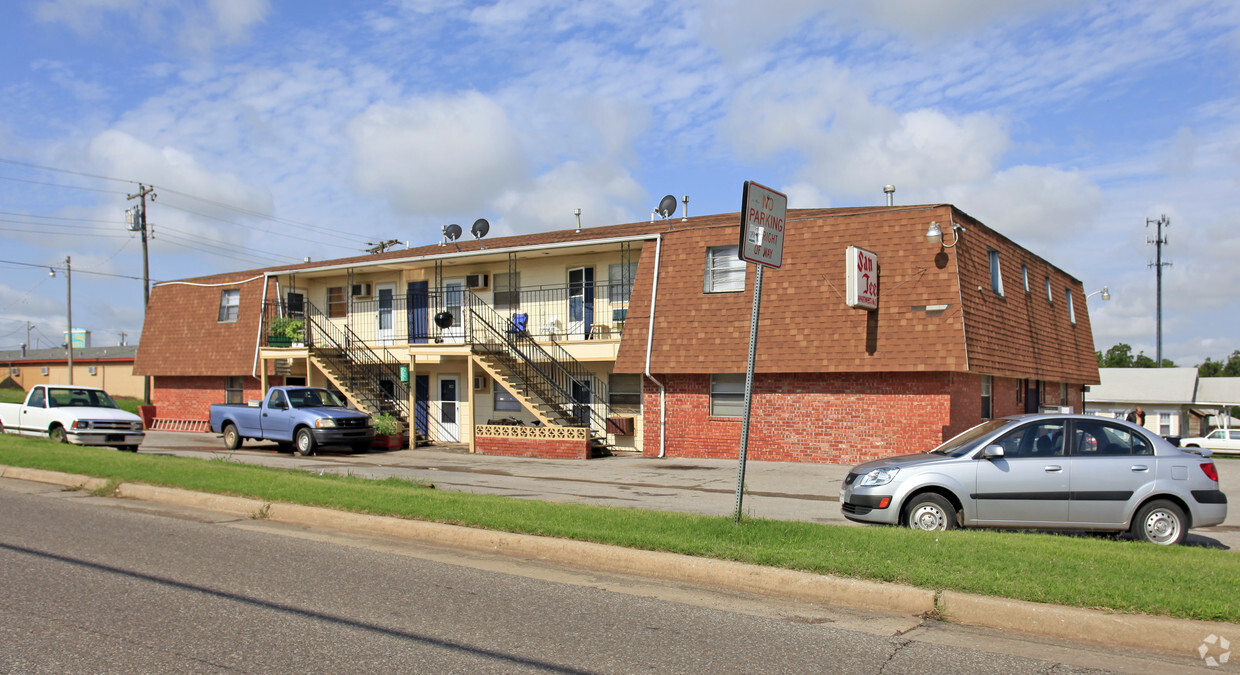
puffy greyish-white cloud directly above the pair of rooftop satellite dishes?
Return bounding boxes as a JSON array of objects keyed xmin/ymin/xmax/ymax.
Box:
[{"xmin": 346, "ymin": 92, "xmax": 526, "ymax": 213}]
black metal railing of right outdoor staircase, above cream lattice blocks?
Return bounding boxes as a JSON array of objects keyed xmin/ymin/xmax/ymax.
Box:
[{"xmin": 469, "ymin": 294, "xmax": 611, "ymax": 438}]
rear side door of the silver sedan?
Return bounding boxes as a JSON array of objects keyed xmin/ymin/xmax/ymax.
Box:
[{"xmin": 1068, "ymin": 419, "xmax": 1157, "ymax": 526}]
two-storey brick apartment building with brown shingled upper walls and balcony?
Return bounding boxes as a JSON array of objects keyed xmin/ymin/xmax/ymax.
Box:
[{"xmin": 135, "ymin": 205, "xmax": 1097, "ymax": 463}]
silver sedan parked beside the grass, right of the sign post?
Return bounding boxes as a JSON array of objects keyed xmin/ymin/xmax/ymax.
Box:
[{"xmin": 839, "ymin": 414, "xmax": 1228, "ymax": 543}]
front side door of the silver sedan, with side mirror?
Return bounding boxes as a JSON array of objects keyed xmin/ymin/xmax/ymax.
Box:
[{"xmin": 971, "ymin": 419, "xmax": 1070, "ymax": 526}]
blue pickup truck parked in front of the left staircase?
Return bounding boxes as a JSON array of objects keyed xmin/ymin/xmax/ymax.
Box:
[{"xmin": 211, "ymin": 387, "xmax": 374, "ymax": 455}]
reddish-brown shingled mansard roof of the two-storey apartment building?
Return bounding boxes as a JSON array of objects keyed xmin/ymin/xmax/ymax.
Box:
[{"xmin": 135, "ymin": 205, "xmax": 1097, "ymax": 383}]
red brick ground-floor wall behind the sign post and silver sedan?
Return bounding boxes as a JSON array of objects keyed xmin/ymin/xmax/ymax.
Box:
[{"xmin": 642, "ymin": 372, "xmax": 962, "ymax": 464}]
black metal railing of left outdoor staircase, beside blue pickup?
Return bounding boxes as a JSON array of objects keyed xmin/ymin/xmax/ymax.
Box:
[{"xmin": 293, "ymin": 302, "xmax": 409, "ymax": 426}]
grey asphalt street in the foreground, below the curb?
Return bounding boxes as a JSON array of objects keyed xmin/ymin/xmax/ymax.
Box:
[{"xmin": 0, "ymin": 479, "xmax": 1202, "ymax": 674}]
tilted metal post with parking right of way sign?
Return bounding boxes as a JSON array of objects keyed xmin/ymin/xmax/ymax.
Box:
[{"xmin": 733, "ymin": 181, "xmax": 787, "ymax": 522}]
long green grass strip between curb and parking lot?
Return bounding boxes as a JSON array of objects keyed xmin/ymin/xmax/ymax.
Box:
[{"xmin": 0, "ymin": 436, "xmax": 1240, "ymax": 623}]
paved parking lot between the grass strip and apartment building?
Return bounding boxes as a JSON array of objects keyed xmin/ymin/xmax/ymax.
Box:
[{"xmin": 139, "ymin": 432, "xmax": 1240, "ymax": 551}]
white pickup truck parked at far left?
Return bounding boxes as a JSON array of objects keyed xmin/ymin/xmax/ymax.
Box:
[{"xmin": 0, "ymin": 385, "xmax": 146, "ymax": 452}]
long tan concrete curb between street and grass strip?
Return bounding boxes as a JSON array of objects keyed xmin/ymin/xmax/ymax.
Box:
[{"xmin": 0, "ymin": 465, "xmax": 1240, "ymax": 658}]
